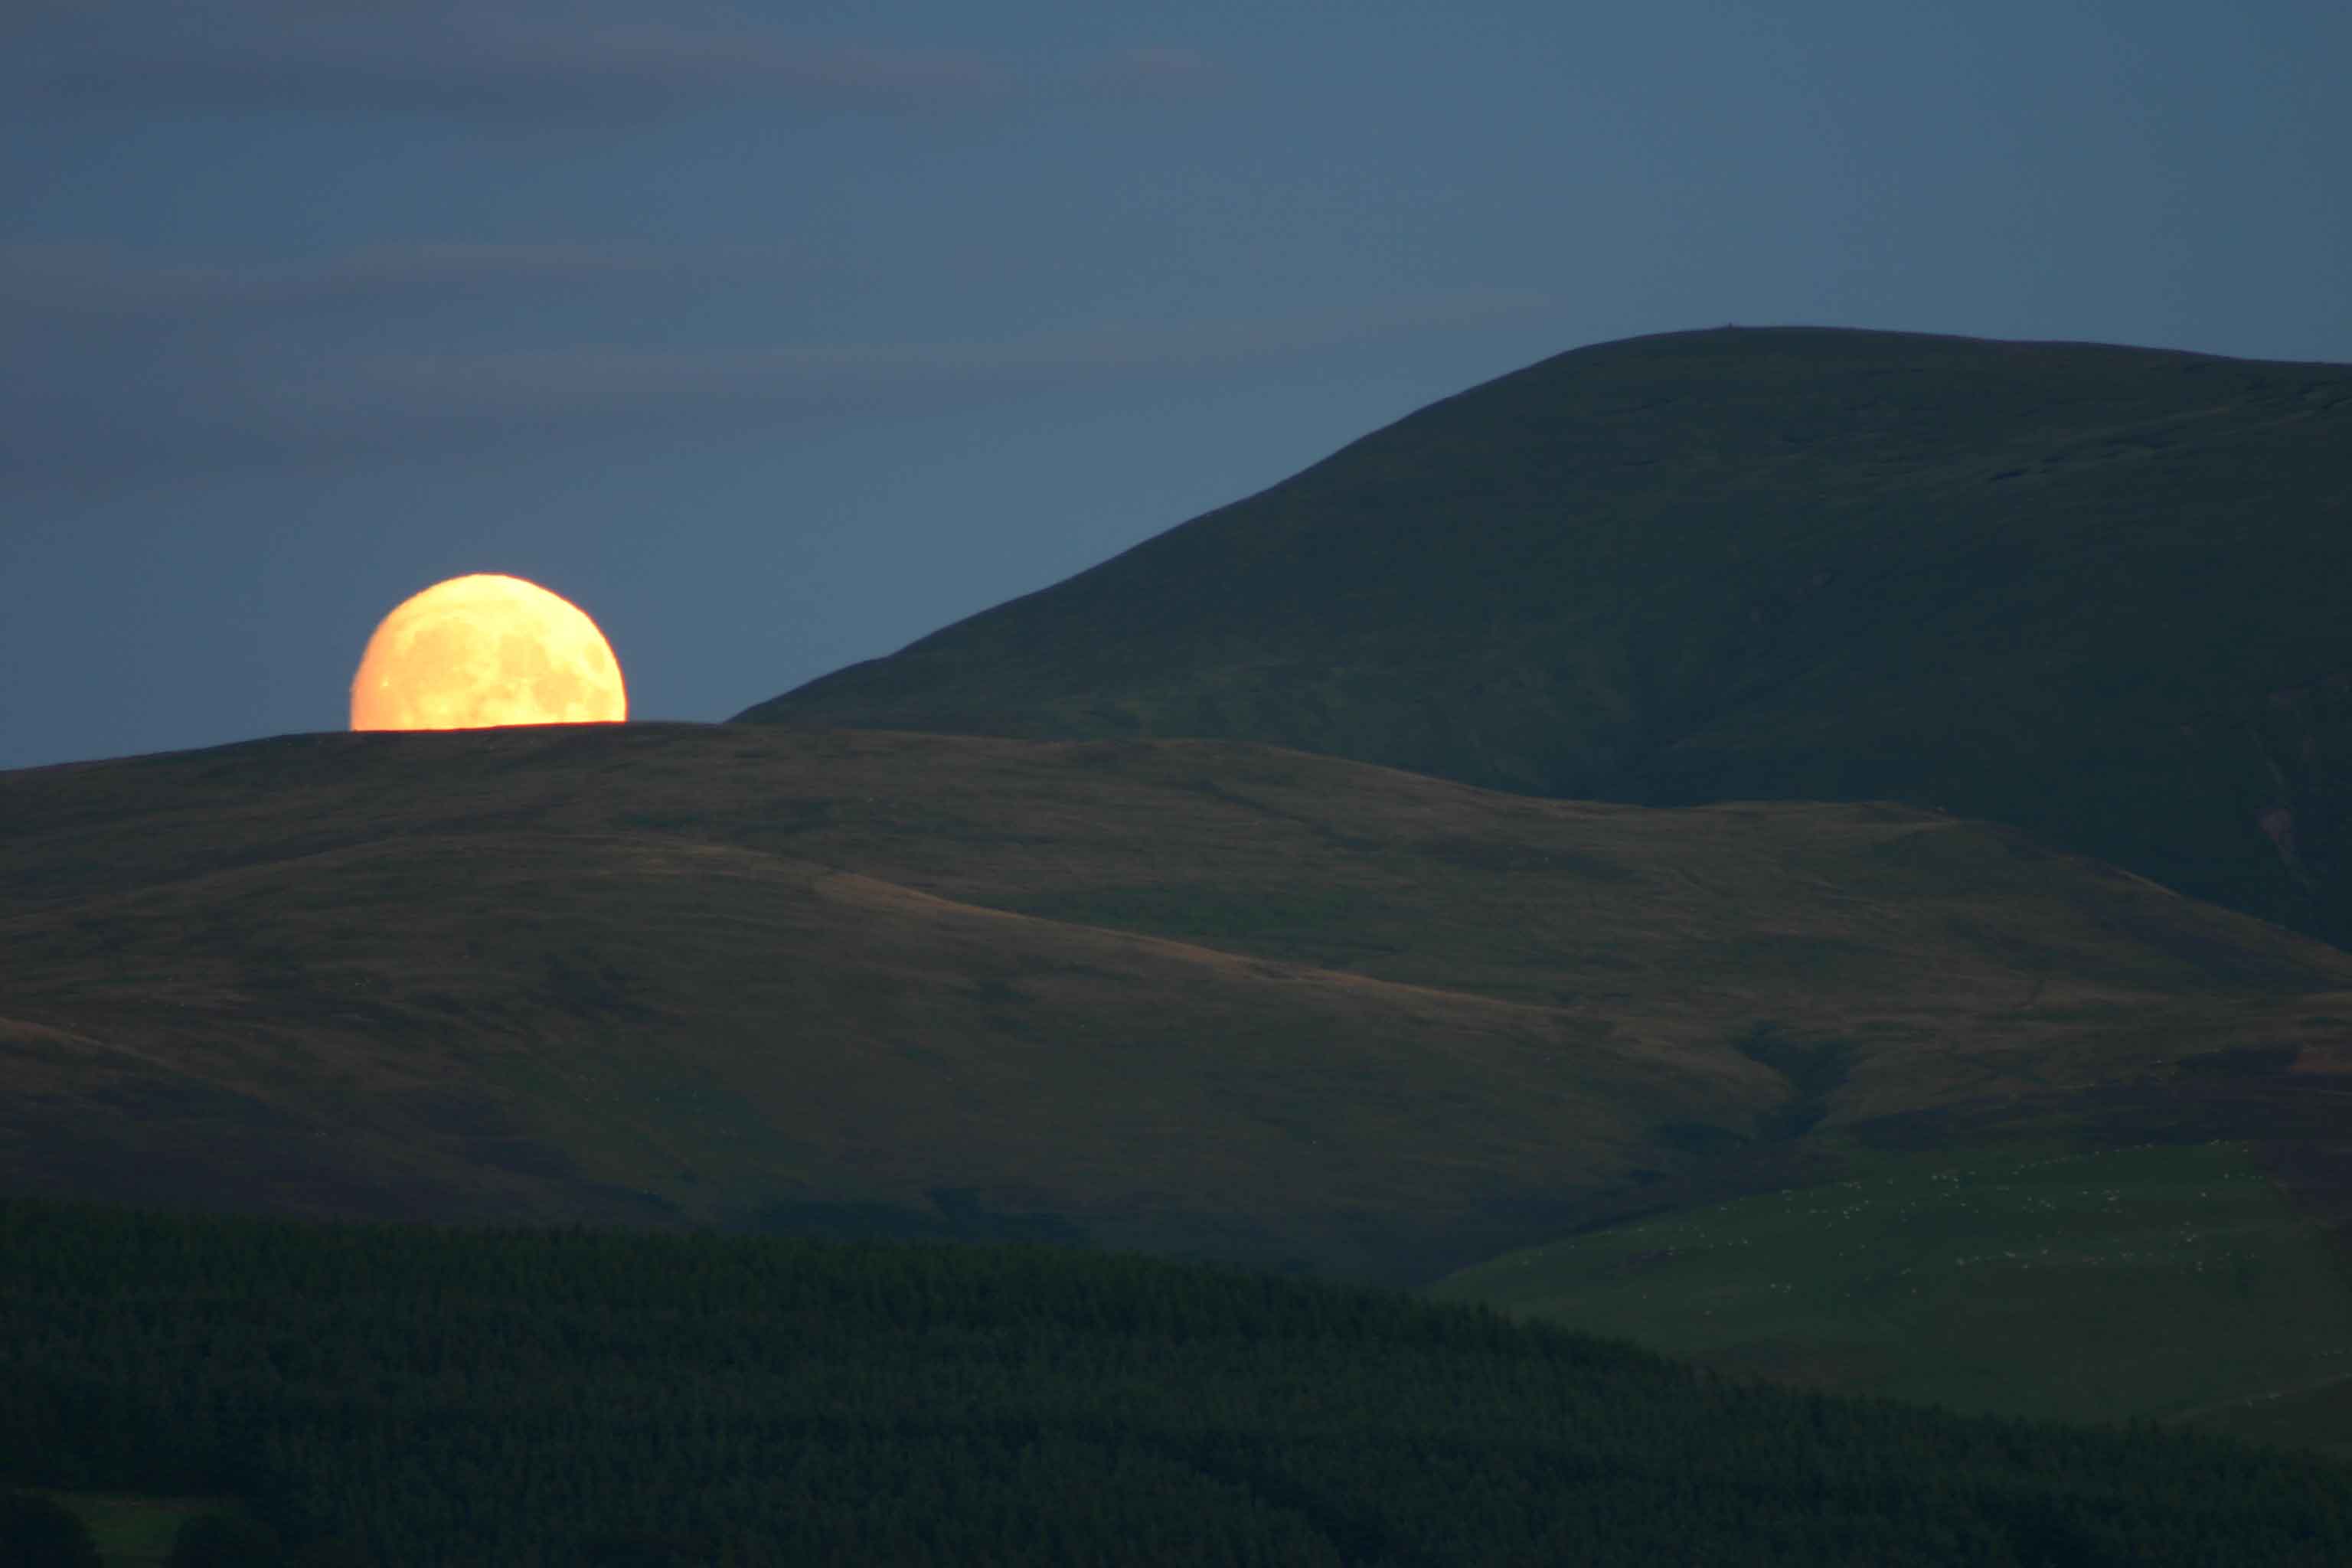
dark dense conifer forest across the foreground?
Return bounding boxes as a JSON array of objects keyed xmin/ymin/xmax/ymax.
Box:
[{"xmin": 0, "ymin": 1201, "xmax": 2352, "ymax": 1568}]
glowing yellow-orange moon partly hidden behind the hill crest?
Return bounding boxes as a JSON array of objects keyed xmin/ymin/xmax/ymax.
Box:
[{"xmin": 351, "ymin": 571, "xmax": 628, "ymax": 729}]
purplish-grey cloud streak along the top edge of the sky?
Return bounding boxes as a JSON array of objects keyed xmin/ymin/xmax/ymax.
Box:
[{"xmin": 18, "ymin": 0, "xmax": 1211, "ymax": 125}]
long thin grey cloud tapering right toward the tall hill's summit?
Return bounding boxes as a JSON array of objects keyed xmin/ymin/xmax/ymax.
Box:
[{"xmin": 0, "ymin": 273, "xmax": 1550, "ymax": 489}]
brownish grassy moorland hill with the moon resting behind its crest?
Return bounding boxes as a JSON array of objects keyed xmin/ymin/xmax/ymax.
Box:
[{"xmin": 0, "ymin": 724, "xmax": 2352, "ymax": 1281}]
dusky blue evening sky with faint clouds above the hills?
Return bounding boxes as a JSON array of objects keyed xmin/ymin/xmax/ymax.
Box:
[{"xmin": 0, "ymin": 0, "xmax": 2352, "ymax": 769}]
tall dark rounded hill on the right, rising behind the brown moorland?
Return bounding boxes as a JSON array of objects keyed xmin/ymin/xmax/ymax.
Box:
[{"xmin": 741, "ymin": 327, "xmax": 2352, "ymax": 942}]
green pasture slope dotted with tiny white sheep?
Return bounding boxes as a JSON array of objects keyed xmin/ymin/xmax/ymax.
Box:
[{"xmin": 1435, "ymin": 1142, "xmax": 2352, "ymax": 1458}]
